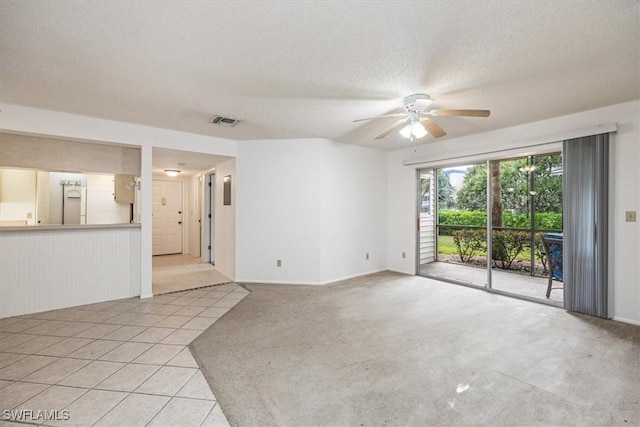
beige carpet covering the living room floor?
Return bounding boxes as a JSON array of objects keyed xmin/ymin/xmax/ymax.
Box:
[{"xmin": 190, "ymin": 273, "xmax": 640, "ymax": 427}]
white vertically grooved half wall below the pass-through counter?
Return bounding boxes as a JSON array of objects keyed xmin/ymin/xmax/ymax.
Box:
[{"xmin": 0, "ymin": 227, "xmax": 141, "ymax": 318}]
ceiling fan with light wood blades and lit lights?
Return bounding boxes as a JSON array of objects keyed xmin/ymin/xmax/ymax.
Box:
[{"xmin": 353, "ymin": 93, "xmax": 490, "ymax": 141}]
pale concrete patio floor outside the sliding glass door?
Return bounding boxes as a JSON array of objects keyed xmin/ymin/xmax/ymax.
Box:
[{"xmin": 419, "ymin": 261, "xmax": 563, "ymax": 306}]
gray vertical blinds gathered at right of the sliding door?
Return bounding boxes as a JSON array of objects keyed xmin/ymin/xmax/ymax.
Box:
[{"xmin": 562, "ymin": 133, "xmax": 609, "ymax": 318}]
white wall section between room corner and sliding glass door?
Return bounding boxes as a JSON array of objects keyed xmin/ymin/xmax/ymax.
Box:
[{"xmin": 319, "ymin": 142, "xmax": 388, "ymax": 283}]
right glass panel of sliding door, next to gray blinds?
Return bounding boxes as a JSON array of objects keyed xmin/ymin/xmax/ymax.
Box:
[{"xmin": 489, "ymin": 154, "xmax": 562, "ymax": 302}]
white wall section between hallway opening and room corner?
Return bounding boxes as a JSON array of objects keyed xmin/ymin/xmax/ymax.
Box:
[{"xmin": 235, "ymin": 140, "xmax": 325, "ymax": 284}]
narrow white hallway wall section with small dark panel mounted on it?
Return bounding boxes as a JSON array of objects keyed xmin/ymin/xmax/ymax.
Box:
[{"xmin": 213, "ymin": 159, "xmax": 238, "ymax": 280}]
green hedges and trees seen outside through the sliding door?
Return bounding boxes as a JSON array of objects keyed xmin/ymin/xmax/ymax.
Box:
[{"xmin": 437, "ymin": 154, "xmax": 562, "ymax": 276}]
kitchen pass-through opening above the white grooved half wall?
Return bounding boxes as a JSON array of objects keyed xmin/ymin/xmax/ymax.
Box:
[{"xmin": 0, "ymin": 168, "xmax": 139, "ymax": 227}]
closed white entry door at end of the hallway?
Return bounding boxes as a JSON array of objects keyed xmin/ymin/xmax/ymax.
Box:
[{"xmin": 153, "ymin": 180, "xmax": 183, "ymax": 255}]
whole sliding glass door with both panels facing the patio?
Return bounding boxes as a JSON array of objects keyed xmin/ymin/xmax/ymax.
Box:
[{"xmin": 418, "ymin": 153, "xmax": 563, "ymax": 304}]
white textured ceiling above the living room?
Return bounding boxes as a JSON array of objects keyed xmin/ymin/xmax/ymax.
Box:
[{"xmin": 0, "ymin": 0, "xmax": 640, "ymax": 150}]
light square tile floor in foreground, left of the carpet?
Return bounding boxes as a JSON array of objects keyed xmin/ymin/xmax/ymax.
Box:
[{"xmin": 0, "ymin": 284, "xmax": 248, "ymax": 427}]
